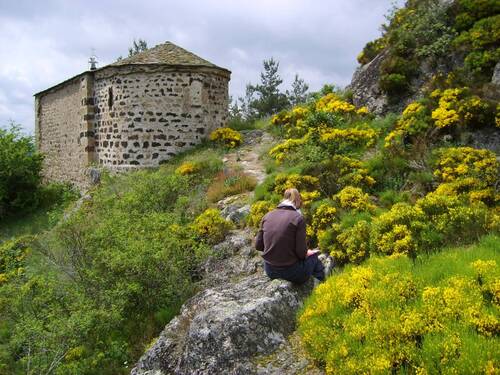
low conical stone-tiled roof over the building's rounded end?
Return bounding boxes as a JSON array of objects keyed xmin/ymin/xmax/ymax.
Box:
[{"xmin": 110, "ymin": 42, "xmax": 227, "ymax": 68}]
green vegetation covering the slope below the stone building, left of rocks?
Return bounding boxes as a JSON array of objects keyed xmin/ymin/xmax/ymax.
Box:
[{"xmin": 0, "ymin": 143, "xmax": 238, "ymax": 374}]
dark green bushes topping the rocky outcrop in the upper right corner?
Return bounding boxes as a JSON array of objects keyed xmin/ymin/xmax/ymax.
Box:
[{"xmin": 358, "ymin": 0, "xmax": 500, "ymax": 102}]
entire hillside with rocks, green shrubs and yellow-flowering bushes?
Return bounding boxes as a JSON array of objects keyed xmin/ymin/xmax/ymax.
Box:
[{"xmin": 0, "ymin": 0, "xmax": 500, "ymax": 374}]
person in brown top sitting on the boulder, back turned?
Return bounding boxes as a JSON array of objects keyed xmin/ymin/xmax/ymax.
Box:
[{"xmin": 255, "ymin": 188, "xmax": 325, "ymax": 284}]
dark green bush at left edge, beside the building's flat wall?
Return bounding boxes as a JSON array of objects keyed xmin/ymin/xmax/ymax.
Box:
[{"xmin": 0, "ymin": 125, "xmax": 43, "ymax": 221}]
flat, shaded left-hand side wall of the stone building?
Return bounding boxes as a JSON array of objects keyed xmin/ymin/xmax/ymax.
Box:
[{"xmin": 35, "ymin": 74, "xmax": 93, "ymax": 187}]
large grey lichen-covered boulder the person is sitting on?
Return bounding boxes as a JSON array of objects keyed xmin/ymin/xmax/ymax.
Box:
[{"xmin": 131, "ymin": 271, "xmax": 313, "ymax": 375}]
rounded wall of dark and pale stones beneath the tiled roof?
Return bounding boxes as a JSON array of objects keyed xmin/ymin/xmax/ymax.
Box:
[{"xmin": 94, "ymin": 66, "xmax": 229, "ymax": 170}]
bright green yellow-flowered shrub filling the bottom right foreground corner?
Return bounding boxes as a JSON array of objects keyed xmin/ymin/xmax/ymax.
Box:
[{"xmin": 299, "ymin": 236, "xmax": 500, "ymax": 374}]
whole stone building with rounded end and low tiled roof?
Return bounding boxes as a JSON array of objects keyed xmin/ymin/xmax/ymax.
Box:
[{"xmin": 35, "ymin": 42, "xmax": 231, "ymax": 187}]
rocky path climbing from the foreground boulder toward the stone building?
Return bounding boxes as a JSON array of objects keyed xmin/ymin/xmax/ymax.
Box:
[{"xmin": 131, "ymin": 130, "xmax": 321, "ymax": 375}]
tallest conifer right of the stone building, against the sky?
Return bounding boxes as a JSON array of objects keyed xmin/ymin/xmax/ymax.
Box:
[{"xmin": 246, "ymin": 58, "xmax": 288, "ymax": 117}]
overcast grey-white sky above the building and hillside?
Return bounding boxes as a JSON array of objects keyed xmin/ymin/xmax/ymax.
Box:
[{"xmin": 0, "ymin": 0, "xmax": 402, "ymax": 132}]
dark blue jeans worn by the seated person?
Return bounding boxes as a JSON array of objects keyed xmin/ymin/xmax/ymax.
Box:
[{"xmin": 264, "ymin": 254, "xmax": 325, "ymax": 284}]
